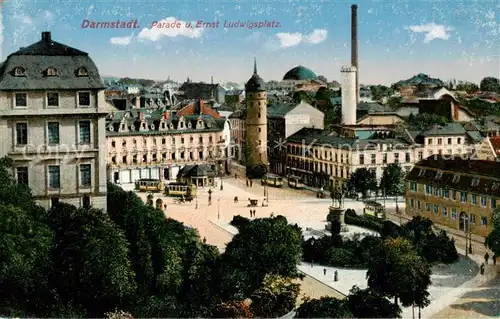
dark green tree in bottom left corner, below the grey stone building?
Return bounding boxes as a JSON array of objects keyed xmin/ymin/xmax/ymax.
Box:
[{"xmin": 0, "ymin": 204, "xmax": 54, "ymax": 317}]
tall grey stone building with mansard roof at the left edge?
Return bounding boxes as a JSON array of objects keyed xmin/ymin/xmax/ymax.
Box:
[{"xmin": 0, "ymin": 32, "xmax": 108, "ymax": 210}]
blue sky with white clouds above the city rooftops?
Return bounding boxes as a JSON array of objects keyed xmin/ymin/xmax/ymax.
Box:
[{"xmin": 0, "ymin": 0, "xmax": 500, "ymax": 85}]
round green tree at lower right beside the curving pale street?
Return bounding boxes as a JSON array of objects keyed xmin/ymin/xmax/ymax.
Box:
[{"xmin": 367, "ymin": 237, "xmax": 431, "ymax": 306}]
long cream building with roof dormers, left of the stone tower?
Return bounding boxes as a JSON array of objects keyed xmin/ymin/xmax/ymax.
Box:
[{"xmin": 106, "ymin": 100, "xmax": 230, "ymax": 184}]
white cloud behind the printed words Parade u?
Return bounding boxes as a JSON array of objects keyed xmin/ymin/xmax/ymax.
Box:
[{"xmin": 138, "ymin": 17, "xmax": 203, "ymax": 42}]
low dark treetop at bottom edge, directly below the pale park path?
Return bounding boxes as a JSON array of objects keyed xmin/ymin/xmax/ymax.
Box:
[{"xmin": 295, "ymin": 297, "xmax": 356, "ymax": 318}]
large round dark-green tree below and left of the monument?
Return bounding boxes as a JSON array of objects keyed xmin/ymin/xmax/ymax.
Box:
[{"xmin": 221, "ymin": 216, "xmax": 302, "ymax": 300}]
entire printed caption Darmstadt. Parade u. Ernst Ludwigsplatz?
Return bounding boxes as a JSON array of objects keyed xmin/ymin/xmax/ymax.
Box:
[{"xmin": 81, "ymin": 19, "xmax": 281, "ymax": 29}]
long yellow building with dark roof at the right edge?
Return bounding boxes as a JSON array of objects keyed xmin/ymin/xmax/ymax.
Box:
[{"xmin": 406, "ymin": 156, "xmax": 500, "ymax": 236}]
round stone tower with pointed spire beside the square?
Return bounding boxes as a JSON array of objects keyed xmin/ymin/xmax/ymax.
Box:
[{"xmin": 245, "ymin": 60, "xmax": 268, "ymax": 172}]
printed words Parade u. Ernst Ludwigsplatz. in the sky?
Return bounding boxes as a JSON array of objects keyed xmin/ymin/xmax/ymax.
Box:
[{"xmin": 151, "ymin": 20, "xmax": 281, "ymax": 29}]
